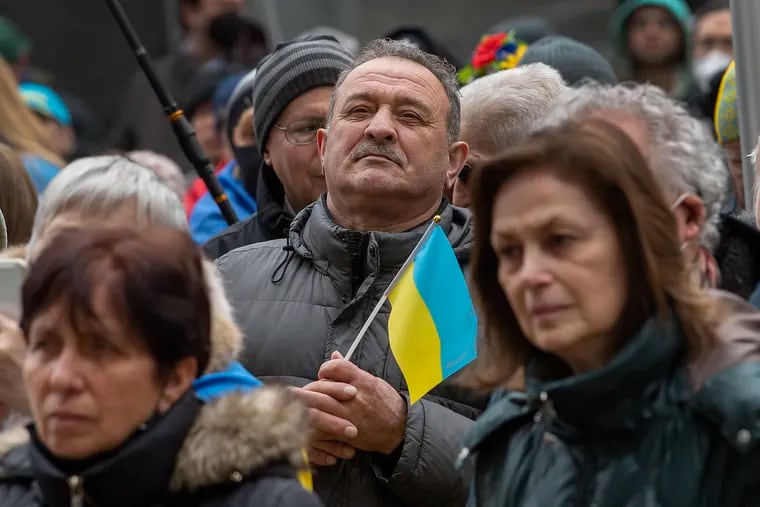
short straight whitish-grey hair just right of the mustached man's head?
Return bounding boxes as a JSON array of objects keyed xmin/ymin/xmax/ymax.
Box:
[{"xmin": 460, "ymin": 63, "xmax": 567, "ymax": 151}]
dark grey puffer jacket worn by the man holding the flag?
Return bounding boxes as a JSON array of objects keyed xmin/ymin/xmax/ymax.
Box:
[{"xmin": 218, "ymin": 196, "xmax": 482, "ymax": 507}]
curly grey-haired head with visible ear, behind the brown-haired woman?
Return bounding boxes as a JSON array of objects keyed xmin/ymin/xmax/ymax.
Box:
[{"xmin": 544, "ymin": 83, "xmax": 728, "ymax": 287}]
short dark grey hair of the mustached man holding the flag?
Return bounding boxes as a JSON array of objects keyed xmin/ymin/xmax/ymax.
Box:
[{"xmin": 327, "ymin": 39, "xmax": 461, "ymax": 143}]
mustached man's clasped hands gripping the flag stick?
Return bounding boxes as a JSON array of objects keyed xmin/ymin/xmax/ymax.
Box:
[{"xmin": 297, "ymin": 352, "xmax": 407, "ymax": 464}]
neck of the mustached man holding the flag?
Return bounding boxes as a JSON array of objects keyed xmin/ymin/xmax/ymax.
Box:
[{"xmin": 327, "ymin": 194, "xmax": 442, "ymax": 232}]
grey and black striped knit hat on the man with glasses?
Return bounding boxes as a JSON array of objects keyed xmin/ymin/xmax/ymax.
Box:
[{"xmin": 253, "ymin": 35, "xmax": 354, "ymax": 155}]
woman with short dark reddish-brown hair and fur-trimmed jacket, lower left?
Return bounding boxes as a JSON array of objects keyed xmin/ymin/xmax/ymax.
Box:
[{"xmin": 0, "ymin": 227, "xmax": 321, "ymax": 507}]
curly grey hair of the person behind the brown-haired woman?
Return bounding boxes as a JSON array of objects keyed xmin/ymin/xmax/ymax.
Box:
[{"xmin": 544, "ymin": 83, "xmax": 728, "ymax": 251}]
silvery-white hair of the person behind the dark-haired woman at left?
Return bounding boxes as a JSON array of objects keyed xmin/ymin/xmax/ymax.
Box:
[{"xmin": 29, "ymin": 155, "xmax": 188, "ymax": 251}]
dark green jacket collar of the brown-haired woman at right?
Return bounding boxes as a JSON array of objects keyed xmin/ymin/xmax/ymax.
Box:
[{"xmin": 526, "ymin": 314, "xmax": 689, "ymax": 431}]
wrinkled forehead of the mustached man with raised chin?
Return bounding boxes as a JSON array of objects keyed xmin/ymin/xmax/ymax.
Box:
[{"xmin": 341, "ymin": 57, "xmax": 446, "ymax": 102}]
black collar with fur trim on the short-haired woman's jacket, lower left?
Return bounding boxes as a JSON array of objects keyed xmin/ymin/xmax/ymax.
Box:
[{"xmin": 30, "ymin": 387, "xmax": 309, "ymax": 507}]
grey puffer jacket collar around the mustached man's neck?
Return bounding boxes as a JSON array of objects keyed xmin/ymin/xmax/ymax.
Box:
[{"xmin": 288, "ymin": 194, "xmax": 472, "ymax": 295}]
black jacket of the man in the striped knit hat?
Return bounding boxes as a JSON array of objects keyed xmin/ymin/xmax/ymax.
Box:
[{"xmin": 203, "ymin": 162, "xmax": 295, "ymax": 259}]
